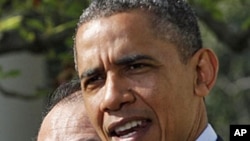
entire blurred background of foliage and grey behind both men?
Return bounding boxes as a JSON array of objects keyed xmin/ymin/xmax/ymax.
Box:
[{"xmin": 0, "ymin": 0, "xmax": 250, "ymax": 141}]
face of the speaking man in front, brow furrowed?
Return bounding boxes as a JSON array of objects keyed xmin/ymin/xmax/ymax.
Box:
[{"xmin": 76, "ymin": 10, "xmax": 202, "ymax": 141}]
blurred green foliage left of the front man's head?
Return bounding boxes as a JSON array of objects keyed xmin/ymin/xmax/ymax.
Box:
[{"xmin": 0, "ymin": 0, "xmax": 89, "ymax": 89}]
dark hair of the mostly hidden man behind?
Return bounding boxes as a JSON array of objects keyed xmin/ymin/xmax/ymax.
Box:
[{"xmin": 44, "ymin": 79, "xmax": 81, "ymax": 117}]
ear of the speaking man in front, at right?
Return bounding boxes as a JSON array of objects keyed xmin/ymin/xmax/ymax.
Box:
[{"xmin": 193, "ymin": 48, "xmax": 218, "ymax": 97}]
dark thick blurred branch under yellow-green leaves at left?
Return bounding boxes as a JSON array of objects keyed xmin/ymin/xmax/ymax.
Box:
[{"xmin": 0, "ymin": 28, "xmax": 74, "ymax": 55}]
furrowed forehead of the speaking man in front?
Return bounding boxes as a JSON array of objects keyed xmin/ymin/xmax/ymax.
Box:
[{"xmin": 75, "ymin": 10, "xmax": 154, "ymax": 72}]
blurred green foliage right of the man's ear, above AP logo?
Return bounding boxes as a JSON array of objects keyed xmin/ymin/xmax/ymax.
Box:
[{"xmin": 190, "ymin": 0, "xmax": 250, "ymax": 140}]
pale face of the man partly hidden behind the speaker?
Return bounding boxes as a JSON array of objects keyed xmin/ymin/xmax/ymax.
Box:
[{"xmin": 38, "ymin": 95, "xmax": 100, "ymax": 141}]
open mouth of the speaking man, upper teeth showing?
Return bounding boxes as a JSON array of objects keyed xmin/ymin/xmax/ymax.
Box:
[{"xmin": 109, "ymin": 119, "xmax": 151, "ymax": 138}]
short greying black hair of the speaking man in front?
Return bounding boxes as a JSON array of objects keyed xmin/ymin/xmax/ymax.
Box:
[{"xmin": 74, "ymin": 0, "xmax": 202, "ymax": 68}]
